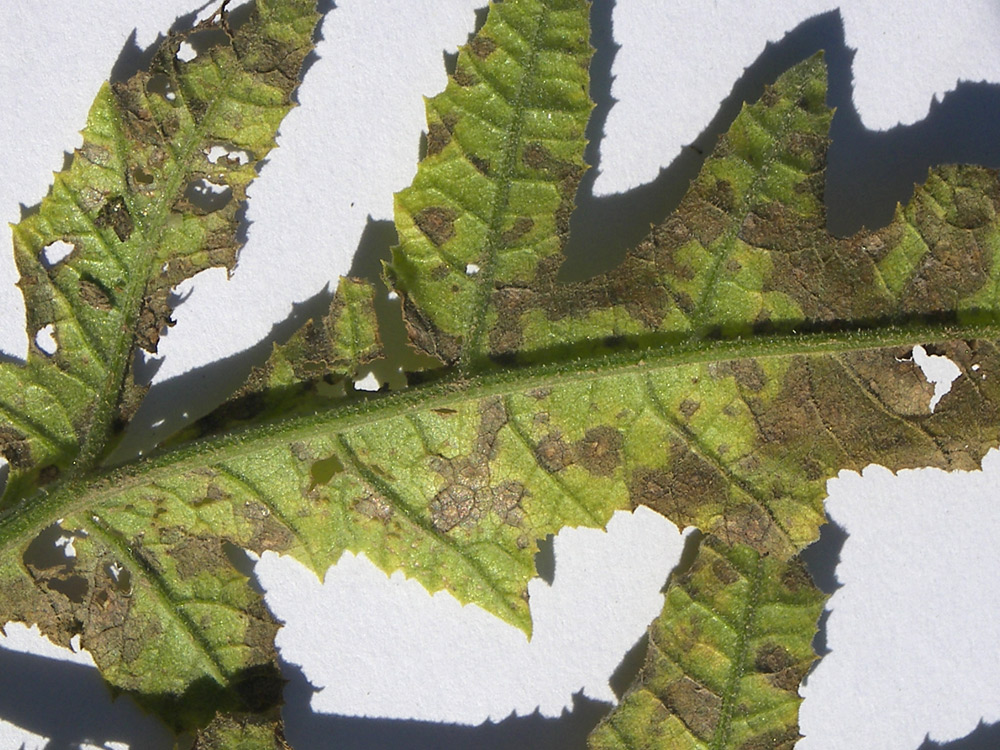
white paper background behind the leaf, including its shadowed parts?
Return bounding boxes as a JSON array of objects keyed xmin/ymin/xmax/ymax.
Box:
[{"xmin": 0, "ymin": 0, "xmax": 1000, "ymax": 750}]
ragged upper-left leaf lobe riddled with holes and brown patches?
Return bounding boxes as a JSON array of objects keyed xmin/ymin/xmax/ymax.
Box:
[{"xmin": 0, "ymin": 0, "xmax": 317, "ymax": 504}]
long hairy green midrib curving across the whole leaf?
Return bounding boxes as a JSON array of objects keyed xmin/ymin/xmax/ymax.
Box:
[{"xmin": 0, "ymin": 323, "xmax": 1000, "ymax": 549}]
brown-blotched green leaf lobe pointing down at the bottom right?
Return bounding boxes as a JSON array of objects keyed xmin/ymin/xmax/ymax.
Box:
[{"xmin": 589, "ymin": 539, "xmax": 826, "ymax": 750}]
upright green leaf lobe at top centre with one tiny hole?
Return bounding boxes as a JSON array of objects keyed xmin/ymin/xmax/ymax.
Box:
[{"xmin": 388, "ymin": 0, "xmax": 593, "ymax": 369}]
